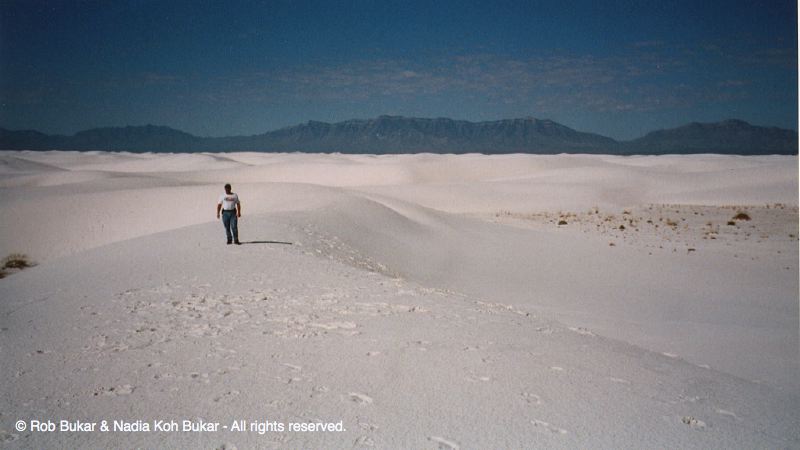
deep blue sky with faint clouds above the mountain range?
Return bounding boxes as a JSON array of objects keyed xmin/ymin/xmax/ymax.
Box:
[{"xmin": 0, "ymin": 0, "xmax": 798, "ymax": 139}]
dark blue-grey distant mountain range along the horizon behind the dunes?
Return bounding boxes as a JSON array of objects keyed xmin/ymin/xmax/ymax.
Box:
[{"xmin": 0, "ymin": 116, "xmax": 798, "ymax": 155}]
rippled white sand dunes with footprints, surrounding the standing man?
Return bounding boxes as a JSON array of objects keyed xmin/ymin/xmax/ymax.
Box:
[{"xmin": 0, "ymin": 152, "xmax": 800, "ymax": 448}]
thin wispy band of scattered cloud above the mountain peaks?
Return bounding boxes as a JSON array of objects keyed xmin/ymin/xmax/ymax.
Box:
[{"xmin": 183, "ymin": 42, "xmax": 786, "ymax": 113}]
